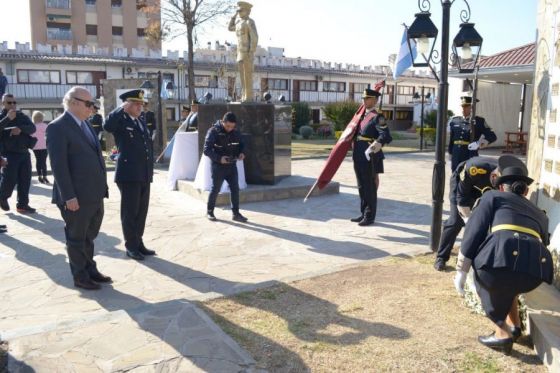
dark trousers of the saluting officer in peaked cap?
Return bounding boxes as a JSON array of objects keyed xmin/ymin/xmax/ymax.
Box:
[{"xmin": 117, "ymin": 182, "xmax": 150, "ymax": 251}]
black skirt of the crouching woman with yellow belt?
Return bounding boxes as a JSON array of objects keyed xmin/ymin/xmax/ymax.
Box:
[{"xmin": 474, "ymin": 268, "xmax": 542, "ymax": 326}]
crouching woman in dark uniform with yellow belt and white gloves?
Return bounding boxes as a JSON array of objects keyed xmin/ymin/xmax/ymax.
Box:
[{"xmin": 454, "ymin": 155, "xmax": 553, "ymax": 354}]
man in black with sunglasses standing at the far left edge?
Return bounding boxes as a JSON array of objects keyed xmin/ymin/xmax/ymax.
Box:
[{"xmin": 0, "ymin": 93, "xmax": 37, "ymax": 214}]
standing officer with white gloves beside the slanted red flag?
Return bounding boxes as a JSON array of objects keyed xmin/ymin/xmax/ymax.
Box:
[{"xmin": 350, "ymin": 88, "xmax": 392, "ymax": 226}]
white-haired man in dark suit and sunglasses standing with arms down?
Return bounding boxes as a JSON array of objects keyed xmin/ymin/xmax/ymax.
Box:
[{"xmin": 47, "ymin": 87, "xmax": 112, "ymax": 290}]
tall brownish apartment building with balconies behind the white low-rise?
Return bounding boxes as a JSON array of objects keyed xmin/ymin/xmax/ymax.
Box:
[{"xmin": 29, "ymin": 0, "xmax": 161, "ymax": 56}]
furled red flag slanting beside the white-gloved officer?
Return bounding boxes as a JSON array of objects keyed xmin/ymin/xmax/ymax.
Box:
[{"xmin": 310, "ymin": 104, "xmax": 365, "ymax": 192}]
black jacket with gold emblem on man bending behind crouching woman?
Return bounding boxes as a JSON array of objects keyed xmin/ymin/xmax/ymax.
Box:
[{"xmin": 449, "ymin": 157, "xmax": 498, "ymax": 208}]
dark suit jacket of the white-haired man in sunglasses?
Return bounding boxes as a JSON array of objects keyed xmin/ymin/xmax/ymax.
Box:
[{"xmin": 47, "ymin": 112, "xmax": 109, "ymax": 205}]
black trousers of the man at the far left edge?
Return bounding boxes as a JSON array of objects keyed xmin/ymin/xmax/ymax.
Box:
[{"xmin": 0, "ymin": 152, "xmax": 31, "ymax": 207}]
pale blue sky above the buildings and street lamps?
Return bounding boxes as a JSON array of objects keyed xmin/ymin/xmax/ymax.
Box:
[{"xmin": 4, "ymin": 0, "xmax": 538, "ymax": 65}]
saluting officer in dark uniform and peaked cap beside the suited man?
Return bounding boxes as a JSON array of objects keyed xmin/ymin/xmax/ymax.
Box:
[{"xmin": 104, "ymin": 89, "xmax": 155, "ymax": 260}]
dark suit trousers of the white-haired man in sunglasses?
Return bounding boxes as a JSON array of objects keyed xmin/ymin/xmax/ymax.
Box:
[{"xmin": 58, "ymin": 200, "xmax": 104, "ymax": 280}]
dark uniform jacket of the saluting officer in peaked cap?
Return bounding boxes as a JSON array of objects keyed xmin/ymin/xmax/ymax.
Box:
[{"xmin": 103, "ymin": 107, "xmax": 154, "ymax": 183}]
